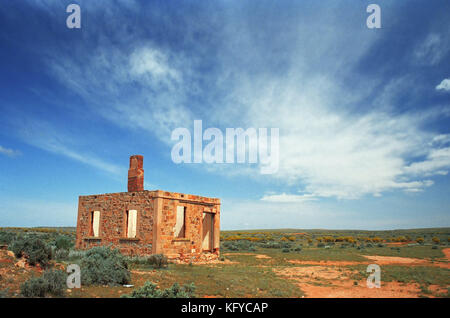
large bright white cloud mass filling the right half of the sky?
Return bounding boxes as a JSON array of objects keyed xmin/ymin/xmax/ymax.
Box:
[{"xmin": 221, "ymin": 74, "xmax": 450, "ymax": 201}]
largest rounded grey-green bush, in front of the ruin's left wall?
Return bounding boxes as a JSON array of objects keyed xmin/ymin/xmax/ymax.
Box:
[{"xmin": 80, "ymin": 246, "xmax": 131, "ymax": 286}]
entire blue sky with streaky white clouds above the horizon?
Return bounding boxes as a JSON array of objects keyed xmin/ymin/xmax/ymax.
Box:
[{"xmin": 0, "ymin": 0, "xmax": 450, "ymax": 229}]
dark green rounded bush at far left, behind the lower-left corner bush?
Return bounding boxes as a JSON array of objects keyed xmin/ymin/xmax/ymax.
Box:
[{"xmin": 10, "ymin": 236, "xmax": 52, "ymax": 267}]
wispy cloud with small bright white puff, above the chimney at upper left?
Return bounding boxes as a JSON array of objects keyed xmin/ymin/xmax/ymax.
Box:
[{"xmin": 48, "ymin": 43, "xmax": 193, "ymax": 143}]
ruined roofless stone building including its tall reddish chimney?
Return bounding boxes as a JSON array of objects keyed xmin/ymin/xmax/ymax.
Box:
[{"xmin": 76, "ymin": 155, "xmax": 220, "ymax": 261}]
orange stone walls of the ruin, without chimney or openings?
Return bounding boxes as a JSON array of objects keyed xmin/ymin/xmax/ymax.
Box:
[{"xmin": 76, "ymin": 190, "xmax": 220, "ymax": 262}]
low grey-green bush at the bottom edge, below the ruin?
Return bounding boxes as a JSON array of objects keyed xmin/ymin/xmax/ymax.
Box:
[{"xmin": 122, "ymin": 281, "xmax": 195, "ymax": 298}]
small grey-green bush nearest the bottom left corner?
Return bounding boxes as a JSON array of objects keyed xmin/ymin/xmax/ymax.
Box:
[{"xmin": 20, "ymin": 270, "xmax": 66, "ymax": 297}]
